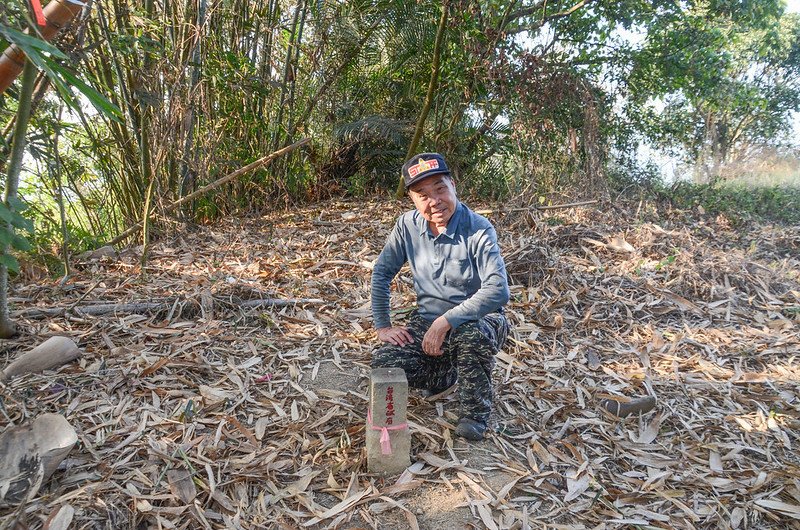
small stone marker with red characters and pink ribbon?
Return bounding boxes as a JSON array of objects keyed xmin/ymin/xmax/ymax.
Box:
[{"xmin": 367, "ymin": 368, "xmax": 411, "ymax": 475}]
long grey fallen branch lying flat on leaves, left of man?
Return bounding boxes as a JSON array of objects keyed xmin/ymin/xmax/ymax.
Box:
[{"xmin": 13, "ymin": 292, "xmax": 324, "ymax": 318}]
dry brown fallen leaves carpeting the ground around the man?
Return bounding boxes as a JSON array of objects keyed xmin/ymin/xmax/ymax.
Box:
[{"xmin": 0, "ymin": 202, "xmax": 800, "ymax": 529}]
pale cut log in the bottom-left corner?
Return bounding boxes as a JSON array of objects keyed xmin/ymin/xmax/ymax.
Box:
[{"xmin": 0, "ymin": 414, "xmax": 78, "ymax": 506}]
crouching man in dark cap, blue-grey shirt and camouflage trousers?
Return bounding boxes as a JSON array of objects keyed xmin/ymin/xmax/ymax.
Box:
[{"xmin": 372, "ymin": 153, "xmax": 509, "ymax": 440}]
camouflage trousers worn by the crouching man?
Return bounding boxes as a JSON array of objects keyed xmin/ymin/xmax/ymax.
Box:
[{"xmin": 372, "ymin": 311, "xmax": 509, "ymax": 422}]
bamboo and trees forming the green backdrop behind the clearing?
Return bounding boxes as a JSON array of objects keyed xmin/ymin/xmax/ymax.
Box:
[{"xmin": 0, "ymin": 0, "xmax": 800, "ymax": 246}]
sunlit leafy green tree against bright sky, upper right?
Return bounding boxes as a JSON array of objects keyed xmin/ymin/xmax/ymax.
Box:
[{"xmin": 626, "ymin": 0, "xmax": 800, "ymax": 179}]
